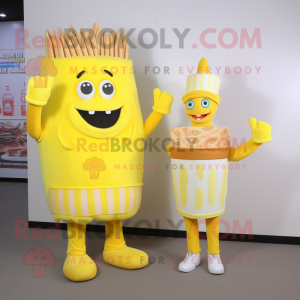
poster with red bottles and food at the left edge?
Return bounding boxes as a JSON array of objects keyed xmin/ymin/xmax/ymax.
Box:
[{"xmin": 0, "ymin": 49, "xmax": 27, "ymax": 178}]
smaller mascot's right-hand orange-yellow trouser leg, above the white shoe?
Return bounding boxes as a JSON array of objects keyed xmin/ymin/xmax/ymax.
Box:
[{"xmin": 206, "ymin": 217, "xmax": 220, "ymax": 255}]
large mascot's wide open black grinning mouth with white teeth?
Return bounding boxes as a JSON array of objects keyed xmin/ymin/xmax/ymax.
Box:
[{"xmin": 77, "ymin": 107, "xmax": 122, "ymax": 129}]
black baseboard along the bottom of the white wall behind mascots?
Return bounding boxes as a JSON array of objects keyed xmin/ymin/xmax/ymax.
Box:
[{"xmin": 28, "ymin": 221, "xmax": 300, "ymax": 245}]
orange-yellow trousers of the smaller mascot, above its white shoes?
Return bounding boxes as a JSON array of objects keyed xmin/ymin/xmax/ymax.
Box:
[{"xmin": 184, "ymin": 217, "xmax": 220, "ymax": 255}]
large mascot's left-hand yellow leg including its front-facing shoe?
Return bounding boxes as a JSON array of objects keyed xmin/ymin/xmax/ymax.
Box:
[{"xmin": 63, "ymin": 223, "xmax": 97, "ymax": 281}]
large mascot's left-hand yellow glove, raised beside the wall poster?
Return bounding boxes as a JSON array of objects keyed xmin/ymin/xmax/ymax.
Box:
[{"xmin": 25, "ymin": 76, "xmax": 54, "ymax": 106}]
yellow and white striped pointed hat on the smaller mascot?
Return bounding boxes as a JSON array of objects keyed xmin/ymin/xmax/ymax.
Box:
[{"xmin": 182, "ymin": 57, "xmax": 221, "ymax": 104}]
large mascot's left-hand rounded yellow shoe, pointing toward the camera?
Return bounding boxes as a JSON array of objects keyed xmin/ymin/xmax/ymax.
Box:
[{"xmin": 63, "ymin": 254, "xmax": 97, "ymax": 281}]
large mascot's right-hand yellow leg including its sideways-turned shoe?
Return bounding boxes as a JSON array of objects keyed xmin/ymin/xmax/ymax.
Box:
[{"xmin": 103, "ymin": 220, "xmax": 149, "ymax": 270}]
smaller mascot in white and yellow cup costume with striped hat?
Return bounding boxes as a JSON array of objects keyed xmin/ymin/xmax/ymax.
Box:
[{"xmin": 168, "ymin": 58, "xmax": 271, "ymax": 274}]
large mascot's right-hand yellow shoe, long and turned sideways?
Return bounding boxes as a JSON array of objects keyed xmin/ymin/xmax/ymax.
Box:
[{"xmin": 103, "ymin": 247, "xmax": 149, "ymax": 270}]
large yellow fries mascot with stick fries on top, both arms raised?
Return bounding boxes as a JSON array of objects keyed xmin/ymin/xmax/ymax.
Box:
[{"xmin": 26, "ymin": 24, "xmax": 173, "ymax": 281}]
